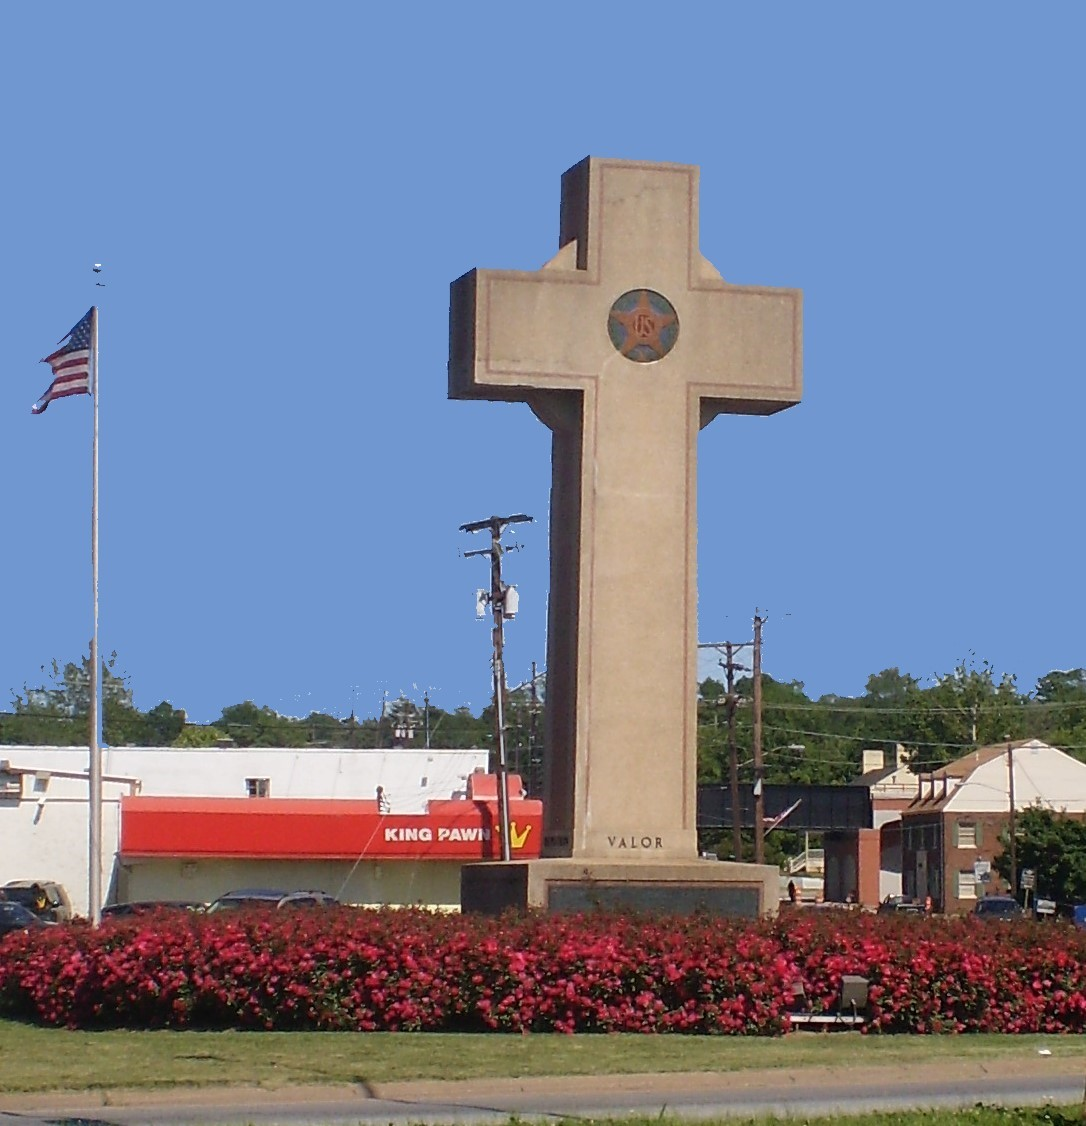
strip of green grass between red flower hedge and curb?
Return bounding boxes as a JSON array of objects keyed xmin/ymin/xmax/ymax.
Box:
[{"xmin": 0, "ymin": 1020, "xmax": 1083, "ymax": 1092}]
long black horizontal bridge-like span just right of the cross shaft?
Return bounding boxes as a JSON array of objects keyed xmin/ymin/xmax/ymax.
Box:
[{"xmin": 697, "ymin": 783, "xmax": 873, "ymax": 832}]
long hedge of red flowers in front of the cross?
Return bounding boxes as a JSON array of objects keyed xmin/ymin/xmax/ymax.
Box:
[{"xmin": 0, "ymin": 909, "xmax": 1086, "ymax": 1036}]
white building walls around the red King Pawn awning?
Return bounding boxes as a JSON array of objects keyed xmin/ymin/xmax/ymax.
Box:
[{"xmin": 0, "ymin": 745, "xmax": 488, "ymax": 914}]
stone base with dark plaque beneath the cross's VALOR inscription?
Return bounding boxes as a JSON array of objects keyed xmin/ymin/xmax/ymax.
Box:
[{"xmin": 460, "ymin": 858, "xmax": 781, "ymax": 919}]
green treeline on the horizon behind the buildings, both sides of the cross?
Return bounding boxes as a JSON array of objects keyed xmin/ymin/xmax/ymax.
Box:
[{"xmin": 0, "ymin": 654, "xmax": 1086, "ymax": 784}]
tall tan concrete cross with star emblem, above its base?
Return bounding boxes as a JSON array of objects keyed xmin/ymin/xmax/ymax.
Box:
[{"xmin": 448, "ymin": 158, "xmax": 801, "ymax": 860}]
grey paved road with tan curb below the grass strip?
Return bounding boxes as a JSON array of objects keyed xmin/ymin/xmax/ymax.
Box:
[{"xmin": 0, "ymin": 1057, "xmax": 1086, "ymax": 1126}]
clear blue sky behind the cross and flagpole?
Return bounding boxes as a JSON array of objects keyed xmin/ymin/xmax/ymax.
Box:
[{"xmin": 0, "ymin": 0, "xmax": 1086, "ymax": 722}]
